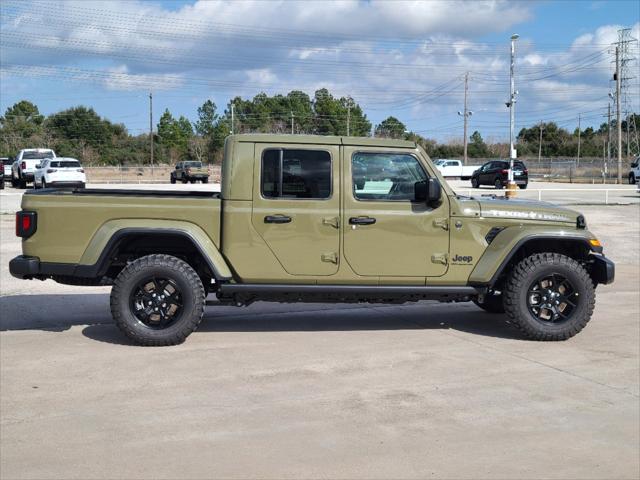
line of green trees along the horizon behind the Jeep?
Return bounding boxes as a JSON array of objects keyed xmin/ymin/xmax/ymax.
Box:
[{"xmin": 0, "ymin": 89, "xmax": 640, "ymax": 165}]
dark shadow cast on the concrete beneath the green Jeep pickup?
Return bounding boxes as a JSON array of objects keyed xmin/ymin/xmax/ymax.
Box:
[{"xmin": 0, "ymin": 294, "xmax": 522, "ymax": 345}]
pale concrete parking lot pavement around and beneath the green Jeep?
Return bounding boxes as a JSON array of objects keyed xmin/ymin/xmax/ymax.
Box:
[{"xmin": 0, "ymin": 182, "xmax": 640, "ymax": 479}]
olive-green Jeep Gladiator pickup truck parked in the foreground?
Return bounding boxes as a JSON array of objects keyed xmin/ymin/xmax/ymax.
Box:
[{"xmin": 9, "ymin": 134, "xmax": 614, "ymax": 345}]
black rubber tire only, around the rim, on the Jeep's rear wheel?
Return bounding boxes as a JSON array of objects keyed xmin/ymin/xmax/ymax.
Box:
[{"xmin": 111, "ymin": 254, "xmax": 205, "ymax": 346}]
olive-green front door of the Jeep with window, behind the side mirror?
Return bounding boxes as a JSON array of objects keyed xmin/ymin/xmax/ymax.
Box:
[{"xmin": 342, "ymin": 147, "xmax": 449, "ymax": 277}]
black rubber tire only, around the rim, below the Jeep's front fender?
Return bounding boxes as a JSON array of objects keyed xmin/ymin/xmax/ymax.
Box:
[{"xmin": 503, "ymin": 253, "xmax": 596, "ymax": 341}]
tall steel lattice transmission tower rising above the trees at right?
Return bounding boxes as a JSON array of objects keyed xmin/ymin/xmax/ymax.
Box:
[{"xmin": 612, "ymin": 28, "xmax": 640, "ymax": 157}]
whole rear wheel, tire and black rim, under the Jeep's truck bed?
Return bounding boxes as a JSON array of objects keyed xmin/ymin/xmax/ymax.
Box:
[{"xmin": 111, "ymin": 255, "xmax": 205, "ymax": 346}]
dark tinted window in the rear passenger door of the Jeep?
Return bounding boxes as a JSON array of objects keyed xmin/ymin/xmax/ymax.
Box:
[{"xmin": 260, "ymin": 148, "xmax": 332, "ymax": 200}]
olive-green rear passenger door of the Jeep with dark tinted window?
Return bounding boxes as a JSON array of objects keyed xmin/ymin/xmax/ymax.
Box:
[{"xmin": 252, "ymin": 144, "xmax": 340, "ymax": 276}]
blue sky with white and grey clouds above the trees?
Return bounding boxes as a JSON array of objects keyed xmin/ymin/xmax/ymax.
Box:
[{"xmin": 0, "ymin": 0, "xmax": 640, "ymax": 141}]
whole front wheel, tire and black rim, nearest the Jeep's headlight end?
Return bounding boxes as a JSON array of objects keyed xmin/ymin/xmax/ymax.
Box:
[{"xmin": 504, "ymin": 253, "xmax": 595, "ymax": 341}]
